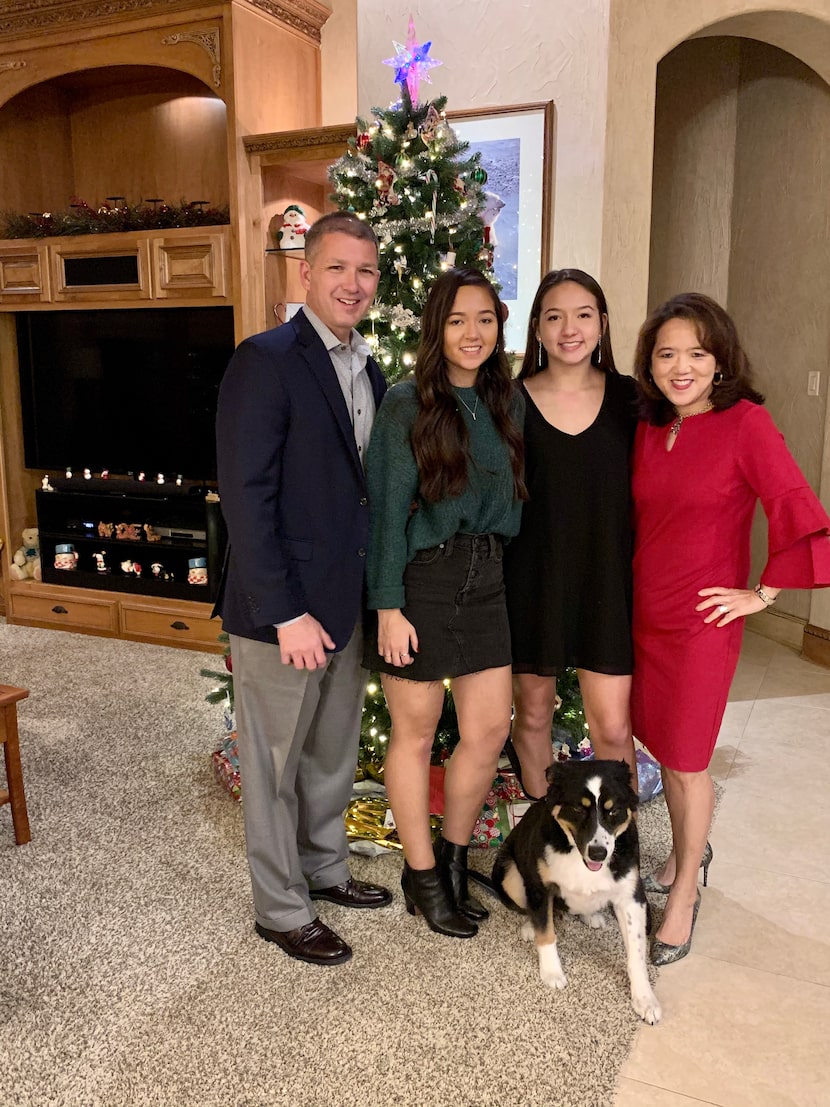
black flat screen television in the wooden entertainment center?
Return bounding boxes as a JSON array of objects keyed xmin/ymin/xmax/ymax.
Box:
[{"xmin": 17, "ymin": 307, "xmax": 234, "ymax": 482}]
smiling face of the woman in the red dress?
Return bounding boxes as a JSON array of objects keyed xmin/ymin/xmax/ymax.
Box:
[{"xmin": 651, "ymin": 319, "xmax": 717, "ymax": 415}]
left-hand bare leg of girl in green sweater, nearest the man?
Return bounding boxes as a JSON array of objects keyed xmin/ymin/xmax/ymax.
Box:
[{"xmin": 381, "ymin": 674, "xmax": 444, "ymax": 869}]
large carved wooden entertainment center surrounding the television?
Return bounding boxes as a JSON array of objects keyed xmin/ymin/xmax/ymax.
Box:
[{"xmin": 0, "ymin": 0, "xmax": 353, "ymax": 651}]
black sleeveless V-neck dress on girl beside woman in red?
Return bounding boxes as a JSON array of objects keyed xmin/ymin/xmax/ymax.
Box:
[{"xmin": 505, "ymin": 374, "xmax": 637, "ymax": 676}]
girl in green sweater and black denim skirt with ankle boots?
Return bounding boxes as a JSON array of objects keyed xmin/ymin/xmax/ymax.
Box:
[{"xmin": 364, "ymin": 269, "xmax": 526, "ymax": 938}]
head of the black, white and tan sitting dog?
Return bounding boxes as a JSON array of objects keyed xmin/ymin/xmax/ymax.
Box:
[{"xmin": 544, "ymin": 761, "xmax": 637, "ymax": 872}]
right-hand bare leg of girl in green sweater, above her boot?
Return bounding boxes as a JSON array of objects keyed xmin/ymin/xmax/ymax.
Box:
[{"xmin": 442, "ymin": 665, "xmax": 511, "ymax": 846}]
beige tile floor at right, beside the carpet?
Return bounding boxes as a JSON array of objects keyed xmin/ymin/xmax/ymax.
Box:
[{"xmin": 615, "ymin": 633, "xmax": 830, "ymax": 1107}]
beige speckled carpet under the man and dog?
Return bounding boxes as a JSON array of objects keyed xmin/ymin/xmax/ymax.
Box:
[{"xmin": 0, "ymin": 622, "xmax": 667, "ymax": 1107}]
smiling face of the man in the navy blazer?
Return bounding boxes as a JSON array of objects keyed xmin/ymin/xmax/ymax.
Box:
[{"xmin": 300, "ymin": 231, "xmax": 380, "ymax": 343}]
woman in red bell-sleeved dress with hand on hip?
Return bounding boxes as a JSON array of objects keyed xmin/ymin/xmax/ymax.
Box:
[{"xmin": 631, "ymin": 292, "xmax": 830, "ymax": 964}]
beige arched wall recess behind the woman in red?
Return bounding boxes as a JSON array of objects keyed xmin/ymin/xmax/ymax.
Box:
[{"xmin": 649, "ymin": 37, "xmax": 830, "ymax": 621}]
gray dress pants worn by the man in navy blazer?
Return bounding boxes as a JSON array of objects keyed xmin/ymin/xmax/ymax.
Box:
[{"xmin": 230, "ymin": 622, "xmax": 366, "ymax": 931}]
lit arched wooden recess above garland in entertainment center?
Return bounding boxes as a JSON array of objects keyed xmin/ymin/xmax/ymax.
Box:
[{"xmin": 0, "ymin": 65, "xmax": 229, "ymax": 220}]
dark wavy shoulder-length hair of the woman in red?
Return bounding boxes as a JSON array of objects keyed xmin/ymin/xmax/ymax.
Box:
[{"xmin": 634, "ymin": 292, "xmax": 764, "ymax": 426}]
